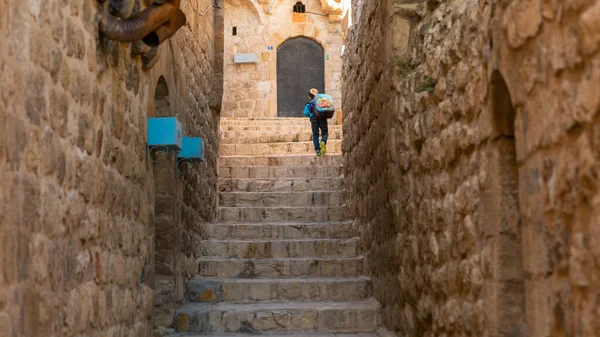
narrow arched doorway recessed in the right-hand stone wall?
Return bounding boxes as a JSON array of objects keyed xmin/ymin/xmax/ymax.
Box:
[{"xmin": 482, "ymin": 71, "xmax": 526, "ymax": 337}]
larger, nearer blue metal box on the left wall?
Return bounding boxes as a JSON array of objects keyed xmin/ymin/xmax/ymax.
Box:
[{"xmin": 148, "ymin": 117, "xmax": 183, "ymax": 151}]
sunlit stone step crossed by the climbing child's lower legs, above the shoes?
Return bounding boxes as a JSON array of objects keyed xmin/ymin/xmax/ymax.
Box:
[{"xmin": 221, "ymin": 130, "xmax": 343, "ymax": 144}]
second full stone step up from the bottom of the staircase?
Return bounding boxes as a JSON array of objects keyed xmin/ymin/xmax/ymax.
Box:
[{"xmin": 186, "ymin": 276, "xmax": 373, "ymax": 303}]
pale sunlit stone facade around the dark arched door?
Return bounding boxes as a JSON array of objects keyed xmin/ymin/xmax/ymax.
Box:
[{"xmin": 222, "ymin": 0, "xmax": 349, "ymax": 117}]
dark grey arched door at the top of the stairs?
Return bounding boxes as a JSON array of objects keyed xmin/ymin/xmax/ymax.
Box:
[{"xmin": 277, "ymin": 37, "xmax": 325, "ymax": 117}]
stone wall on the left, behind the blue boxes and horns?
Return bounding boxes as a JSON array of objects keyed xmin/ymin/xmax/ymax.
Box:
[{"xmin": 0, "ymin": 0, "xmax": 222, "ymax": 337}]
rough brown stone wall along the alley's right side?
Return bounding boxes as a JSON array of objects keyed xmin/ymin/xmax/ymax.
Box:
[{"xmin": 343, "ymin": 0, "xmax": 600, "ymax": 337}]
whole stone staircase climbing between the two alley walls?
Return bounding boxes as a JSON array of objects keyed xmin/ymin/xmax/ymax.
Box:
[{"xmin": 174, "ymin": 118, "xmax": 380, "ymax": 337}]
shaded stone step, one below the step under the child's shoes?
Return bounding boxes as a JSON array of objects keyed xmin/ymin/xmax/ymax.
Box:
[{"xmin": 219, "ymin": 166, "xmax": 342, "ymax": 179}]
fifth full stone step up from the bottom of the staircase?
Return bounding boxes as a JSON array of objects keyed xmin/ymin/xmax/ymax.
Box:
[{"xmin": 206, "ymin": 221, "xmax": 357, "ymax": 240}]
